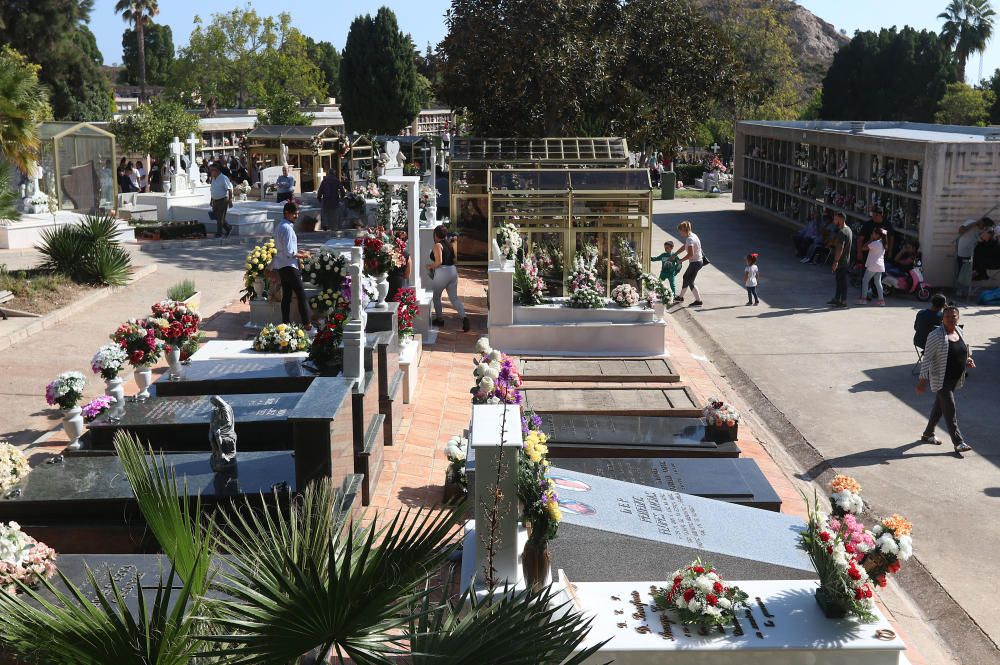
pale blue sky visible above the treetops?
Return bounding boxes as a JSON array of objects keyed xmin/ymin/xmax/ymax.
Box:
[{"xmin": 90, "ymin": 0, "xmax": 1000, "ymax": 83}]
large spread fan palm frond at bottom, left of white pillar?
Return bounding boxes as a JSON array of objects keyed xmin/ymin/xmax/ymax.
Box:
[{"xmin": 208, "ymin": 480, "xmax": 464, "ymax": 665}]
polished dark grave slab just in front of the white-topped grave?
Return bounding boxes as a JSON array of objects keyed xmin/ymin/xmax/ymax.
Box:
[{"xmin": 150, "ymin": 358, "xmax": 324, "ymax": 397}]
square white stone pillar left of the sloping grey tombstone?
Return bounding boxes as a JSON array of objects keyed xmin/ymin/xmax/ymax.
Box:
[{"xmin": 469, "ymin": 404, "xmax": 522, "ymax": 588}]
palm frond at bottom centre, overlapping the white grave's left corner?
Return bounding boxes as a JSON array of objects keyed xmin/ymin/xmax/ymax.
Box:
[{"xmin": 409, "ymin": 585, "xmax": 608, "ymax": 665}]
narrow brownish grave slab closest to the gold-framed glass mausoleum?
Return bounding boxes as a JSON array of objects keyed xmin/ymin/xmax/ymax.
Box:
[{"xmin": 520, "ymin": 358, "xmax": 680, "ymax": 383}]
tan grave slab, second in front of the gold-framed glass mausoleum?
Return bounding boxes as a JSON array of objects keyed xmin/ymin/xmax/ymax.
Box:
[{"xmin": 521, "ymin": 386, "xmax": 702, "ymax": 418}]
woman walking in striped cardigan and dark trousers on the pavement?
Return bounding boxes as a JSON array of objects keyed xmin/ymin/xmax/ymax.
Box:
[{"xmin": 917, "ymin": 305, "xmax": 976, "ymax": 453}]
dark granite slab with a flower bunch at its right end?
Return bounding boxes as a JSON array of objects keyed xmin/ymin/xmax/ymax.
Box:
[{"xmin": 539, "ymin": 413, "xmax": 740, "ymax": 458}]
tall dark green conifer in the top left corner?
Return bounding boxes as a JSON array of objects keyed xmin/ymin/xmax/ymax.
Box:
[{"xmin": 0, "ymin": 0, "xmax": 114, "ymax": 121}]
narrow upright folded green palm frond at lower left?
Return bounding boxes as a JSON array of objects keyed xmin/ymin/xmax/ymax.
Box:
[{"xmin": 115, "ymin": 432, "xmax": 215, "ymax": 597}]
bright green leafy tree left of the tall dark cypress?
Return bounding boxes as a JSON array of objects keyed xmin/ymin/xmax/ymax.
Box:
[{"xmin": 170, "ymin": 8, "xmax": 324, "ymax": 108}]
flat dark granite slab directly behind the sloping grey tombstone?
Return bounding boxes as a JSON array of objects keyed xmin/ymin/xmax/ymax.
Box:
[{"xmin": 552, "ymin": 457, "xmax": 781, "ymax": 512}]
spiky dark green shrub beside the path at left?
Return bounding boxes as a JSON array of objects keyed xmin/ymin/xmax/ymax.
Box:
[{"xmin": 37, "ymin": 215, "xmax": 132, "ymax": 286}]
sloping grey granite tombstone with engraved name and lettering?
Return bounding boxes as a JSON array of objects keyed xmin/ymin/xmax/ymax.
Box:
[{"xmin": 549, "ymin": 469, "xmax": 815, "ymax": 582}]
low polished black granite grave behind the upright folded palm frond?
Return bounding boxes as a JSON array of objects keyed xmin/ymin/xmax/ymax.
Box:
[{"xmin": 0, "ymin": 451, "xmax": 294, "ymax": 553}]
